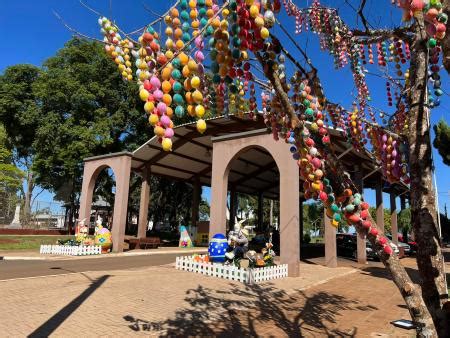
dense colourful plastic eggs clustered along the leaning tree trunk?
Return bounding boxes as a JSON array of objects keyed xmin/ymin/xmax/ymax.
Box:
[{"xmin": 263, "ymin": 72, "xmax": 392, "ymax": 255}]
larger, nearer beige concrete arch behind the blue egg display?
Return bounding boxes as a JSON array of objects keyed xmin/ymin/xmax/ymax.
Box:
[{"xmin": 210, "ymin": 131, "xmax": 300, "ymax": 276}]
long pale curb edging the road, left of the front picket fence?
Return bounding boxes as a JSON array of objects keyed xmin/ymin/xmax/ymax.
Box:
[{"xmin": 0, "ymin": 248, "xmax": 208, "ymax": 261}]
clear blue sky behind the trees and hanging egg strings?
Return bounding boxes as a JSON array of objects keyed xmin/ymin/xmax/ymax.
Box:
[{"xmin": 0, "ymin": 0, "xmax": 450, "ymax": 214}]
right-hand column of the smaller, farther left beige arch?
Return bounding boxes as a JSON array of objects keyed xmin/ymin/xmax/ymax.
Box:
[{"xmin": 111, "ymin": 156, "xmax": 131, "ymax": 252}]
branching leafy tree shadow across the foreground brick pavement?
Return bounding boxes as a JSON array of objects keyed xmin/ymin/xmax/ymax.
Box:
[{"xmin": 123, "ymin": 283, "xmax": 377, "ymax": 337}]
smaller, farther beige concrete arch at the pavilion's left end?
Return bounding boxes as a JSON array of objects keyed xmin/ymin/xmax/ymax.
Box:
[{"xmin": 79, "ymin": 153, "xmax": 132, "ymax": 252}]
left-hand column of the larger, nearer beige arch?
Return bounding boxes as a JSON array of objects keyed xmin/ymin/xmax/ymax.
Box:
[{"xmin": 209, "ymin": 143, "xmax": 228, "ymax": 239}]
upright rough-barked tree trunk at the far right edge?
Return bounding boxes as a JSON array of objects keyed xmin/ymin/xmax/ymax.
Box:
[{"xmin": 408, "ymin": 15, "xmax": 450, "ymax": 336}]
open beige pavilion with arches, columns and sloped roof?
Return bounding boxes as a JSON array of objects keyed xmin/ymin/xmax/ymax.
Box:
[{"xmin": 79, "ymin": 115, "xmax": 407, "ymax": 275}]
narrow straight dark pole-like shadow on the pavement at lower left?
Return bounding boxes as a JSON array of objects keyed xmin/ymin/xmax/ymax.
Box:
[{"xmin": 28, "ymin": 275, "xmax": 110, "ymax": 338}]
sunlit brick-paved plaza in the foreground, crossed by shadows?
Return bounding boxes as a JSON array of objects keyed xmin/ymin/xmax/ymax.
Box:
[{"xmin": 0, "ymin": 260, "xmax": 428, "ymax": 337}]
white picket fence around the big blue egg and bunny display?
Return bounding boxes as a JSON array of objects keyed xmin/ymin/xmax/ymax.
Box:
[{"xmin": 175, "ymin": 256, "xmax": 288, "ymax": 284}]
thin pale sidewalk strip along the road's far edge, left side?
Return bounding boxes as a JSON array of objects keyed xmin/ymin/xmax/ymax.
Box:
[{"xmin": 0, "ymin": 247, "xmax": 208, "ymax": 260}]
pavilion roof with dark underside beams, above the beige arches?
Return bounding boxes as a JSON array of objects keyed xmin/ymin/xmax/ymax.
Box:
[{"xmin": 86, "ymin": 114, "xmax": 407, "ymax": 199}]
